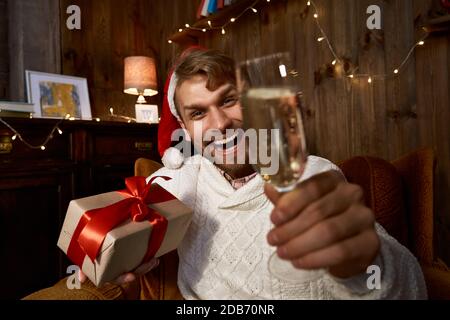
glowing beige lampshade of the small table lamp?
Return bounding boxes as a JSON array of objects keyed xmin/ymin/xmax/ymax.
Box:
[{"xmin": 124, "ymin": 56, "xmax": 158, "ymax": 96}]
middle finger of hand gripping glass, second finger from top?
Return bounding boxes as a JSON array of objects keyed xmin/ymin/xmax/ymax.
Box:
[{"xmin": 267, "ymin": 184, "xmax": 366, "ymax": 246}]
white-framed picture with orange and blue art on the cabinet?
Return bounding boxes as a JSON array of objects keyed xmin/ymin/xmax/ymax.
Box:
[{"xmin": 25, "ymin": 70, "xmax": 92, "ymax": 120}]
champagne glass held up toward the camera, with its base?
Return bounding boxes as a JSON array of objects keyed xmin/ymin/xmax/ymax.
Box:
[{"xmin": 236, "ymin": 52, "xmax": 324, "ymax": 282}]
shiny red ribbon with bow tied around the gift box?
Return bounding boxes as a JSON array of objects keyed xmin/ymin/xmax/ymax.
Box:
[{"xmin": 67, "ymin": 176, "xmax": 176, "ymax": 267}]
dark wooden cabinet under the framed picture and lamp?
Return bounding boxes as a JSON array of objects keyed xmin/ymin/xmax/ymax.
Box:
[{"xmin": 0, "ymin": 118, "xmax": 160, "ymax": 299}]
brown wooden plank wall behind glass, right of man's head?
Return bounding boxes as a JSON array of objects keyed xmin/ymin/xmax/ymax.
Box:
[{"xmin": 152, "ymin": 0, "xmax": 450, "ymax": 262}]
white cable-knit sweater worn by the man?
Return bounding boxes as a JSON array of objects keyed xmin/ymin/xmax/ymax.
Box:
[{"xmin": 147, "ymin": 155, "xmax": 426, "ymax": 299}]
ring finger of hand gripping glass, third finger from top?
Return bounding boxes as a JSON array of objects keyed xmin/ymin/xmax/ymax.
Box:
[{"xmin": 277, "ymin": 205, "xmax": 375, "ymax": 260}]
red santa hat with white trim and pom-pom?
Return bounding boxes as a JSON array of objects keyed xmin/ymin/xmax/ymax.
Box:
[{"xmin": 158, "ymin": 46, "xmax": 206, "ymax": 169}]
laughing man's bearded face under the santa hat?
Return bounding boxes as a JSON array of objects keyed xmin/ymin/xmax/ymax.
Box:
[{"xmin": 176, "ymin": 75, "xmax": 253, "ymax": 176}]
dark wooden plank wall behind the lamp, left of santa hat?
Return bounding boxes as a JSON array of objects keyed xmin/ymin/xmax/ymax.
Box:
[{"xmin": 60, "ymin": 0, "xmax": 197, "ymax": 118}]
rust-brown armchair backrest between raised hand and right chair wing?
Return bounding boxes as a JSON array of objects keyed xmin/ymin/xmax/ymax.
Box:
[{"xmin": 340, "ymin": 156, "xmax": 408, "ymax": 246}]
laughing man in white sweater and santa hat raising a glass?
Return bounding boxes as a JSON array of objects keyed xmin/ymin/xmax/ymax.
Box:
[{"xmin": 143, "ymin": 49, "xmax": 426, "ymax": 299}]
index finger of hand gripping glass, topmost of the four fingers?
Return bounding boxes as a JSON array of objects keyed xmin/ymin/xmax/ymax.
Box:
[{"xmin": 270, "ymin": 170, "xmax": 344, "ymax": 225}]
